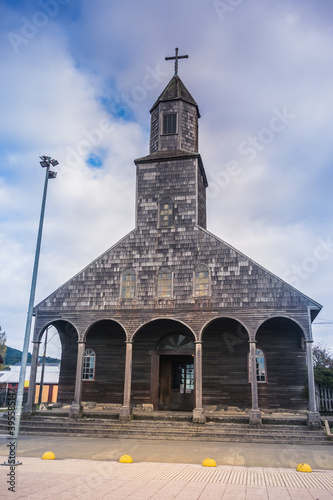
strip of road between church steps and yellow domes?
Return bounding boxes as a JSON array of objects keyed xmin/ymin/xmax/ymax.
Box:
[{"xmin": 0, "ymin": 436, "xmax": 333, "ymax": 470}]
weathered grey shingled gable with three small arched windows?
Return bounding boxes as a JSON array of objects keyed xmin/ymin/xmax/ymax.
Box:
[{"xmin": 36, "ymin": 226, "xmax": 320, "ymax": 311}]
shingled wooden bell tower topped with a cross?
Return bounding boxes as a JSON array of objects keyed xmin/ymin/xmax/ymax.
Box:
[{"xmin": 135, "ymin": 49, "xmax": 208, "ymax": 229}]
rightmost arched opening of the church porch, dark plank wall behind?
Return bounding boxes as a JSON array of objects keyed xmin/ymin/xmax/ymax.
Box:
[{"xmin": 256, "ymin": 317, "xmax": 307, "ymax": 410}]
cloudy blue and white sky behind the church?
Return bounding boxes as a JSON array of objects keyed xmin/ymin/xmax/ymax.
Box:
[{"xmin": 0, "ymin": 0, "xmax": 333, "ymax": 360}]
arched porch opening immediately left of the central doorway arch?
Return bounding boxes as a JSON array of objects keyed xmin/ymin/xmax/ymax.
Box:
[{"xmin": 82, "ymin": 320, "xmax": 126, "ymax": 404}]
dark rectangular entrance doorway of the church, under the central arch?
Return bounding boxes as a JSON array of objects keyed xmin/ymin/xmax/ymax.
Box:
[{"xmin": 158, "ymin": 355, "xmax": 194, "ymax": 411}]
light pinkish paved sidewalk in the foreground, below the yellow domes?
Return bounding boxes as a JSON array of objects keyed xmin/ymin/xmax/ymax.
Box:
[{"xmin": 0, "ymin": 456, "xmax": 333, "ymax": 500}]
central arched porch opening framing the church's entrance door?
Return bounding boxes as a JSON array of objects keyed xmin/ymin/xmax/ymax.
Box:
[{"xmin": 132, "ymin": 319, "xmax": 195, "ymax": 411}]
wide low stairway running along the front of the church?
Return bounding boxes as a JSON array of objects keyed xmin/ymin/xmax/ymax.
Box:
[{"xmin": 0, "ymin": 414, "xmax": 326, "ymax": 446}]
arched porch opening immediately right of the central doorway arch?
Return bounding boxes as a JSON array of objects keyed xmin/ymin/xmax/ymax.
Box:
[{"xmin": 202, "ymin": 318, "xmax": 252, "ymax": 409}]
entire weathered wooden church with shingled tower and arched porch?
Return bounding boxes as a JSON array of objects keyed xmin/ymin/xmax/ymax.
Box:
[{"xmin": 25, "ymin": 49, "xmax": 321, "ymax": 426}]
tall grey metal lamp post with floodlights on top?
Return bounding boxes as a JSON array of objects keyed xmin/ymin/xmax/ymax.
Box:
[{"xmin": 1, "ymin": 156, "xmax": 59, "ymax": 466}]
